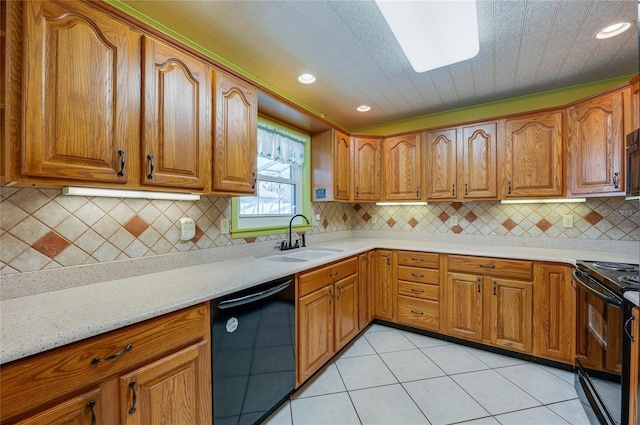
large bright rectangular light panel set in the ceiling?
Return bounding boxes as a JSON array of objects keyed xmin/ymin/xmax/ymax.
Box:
[{"xmin": 376, "ymin": 0, "xmax": 480, "ymax": 72}]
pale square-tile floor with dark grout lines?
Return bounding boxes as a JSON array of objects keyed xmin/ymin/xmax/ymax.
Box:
[{"xmin": 265, "ymin": 324, "xmax": 589, "ymax": 425}]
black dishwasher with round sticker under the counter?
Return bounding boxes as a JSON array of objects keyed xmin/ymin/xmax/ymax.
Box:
[{"xmin": 211, "ymin": 276, "xmax": 296, "ymax": 425}]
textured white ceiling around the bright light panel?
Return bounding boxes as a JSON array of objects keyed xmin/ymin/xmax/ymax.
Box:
[{"xmin": 125, "ymin": 0, "xmax": 638, "ymax": 130}]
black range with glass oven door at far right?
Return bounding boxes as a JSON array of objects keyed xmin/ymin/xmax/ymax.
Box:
[{"xmin": 573, "ymin": 261, "xmax": 639, "ymax": 425}]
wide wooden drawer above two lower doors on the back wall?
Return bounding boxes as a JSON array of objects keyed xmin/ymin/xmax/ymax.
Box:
[{"xmin": 449, "ymin": 255, "xmax": 533, "ymax": 280}]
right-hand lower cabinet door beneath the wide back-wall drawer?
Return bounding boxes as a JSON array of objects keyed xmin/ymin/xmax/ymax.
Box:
[{"xmin": 491, "ymin": 279, "xmax": 533, "ymax": 353}]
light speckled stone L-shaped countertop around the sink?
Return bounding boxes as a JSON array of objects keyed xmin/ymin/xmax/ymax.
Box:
[{"xmin": 0, "ymin": 238, "xmax": 637, "ymax": 364}]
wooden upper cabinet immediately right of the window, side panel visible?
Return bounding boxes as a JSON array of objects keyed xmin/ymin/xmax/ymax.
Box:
[{"xmin": 311, "ymin": 129, "xmax": 352, "ymax": 202}]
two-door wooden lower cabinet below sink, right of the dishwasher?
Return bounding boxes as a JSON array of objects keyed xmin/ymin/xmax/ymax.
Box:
[{"xmin": 296, "ymin": 257, "xmax": 359, "ymax": 385}]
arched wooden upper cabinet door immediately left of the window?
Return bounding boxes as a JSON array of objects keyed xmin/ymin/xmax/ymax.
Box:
[{"xmin": 213, "ymin": 72, "xmax": 258, "ymax": 195}]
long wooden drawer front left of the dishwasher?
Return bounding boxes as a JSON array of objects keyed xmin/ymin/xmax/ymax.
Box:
[{"xmin": 0, "ymin": 303, "xmax": 211, "ymax": 421}]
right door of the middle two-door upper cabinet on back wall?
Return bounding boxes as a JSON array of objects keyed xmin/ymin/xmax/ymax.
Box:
[{"xmin": 462, "ymin": 122, "xmax": 498, "ymax": 198}]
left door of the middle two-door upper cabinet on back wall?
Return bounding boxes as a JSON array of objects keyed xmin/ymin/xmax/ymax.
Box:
[{"xmin": 426, "ymin": 128, "xmax": 458, "ymax": 200}]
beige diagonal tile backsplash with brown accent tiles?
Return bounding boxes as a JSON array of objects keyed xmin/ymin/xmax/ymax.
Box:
[{"xmin": 0, "ymin": 187, "xmax": 640, "ymax": 275}]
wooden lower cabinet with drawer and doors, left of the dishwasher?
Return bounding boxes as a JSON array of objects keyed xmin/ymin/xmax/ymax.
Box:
[{"xmin": 0, "ymin": 303, "xmax": 212, "ymax": 425}]
